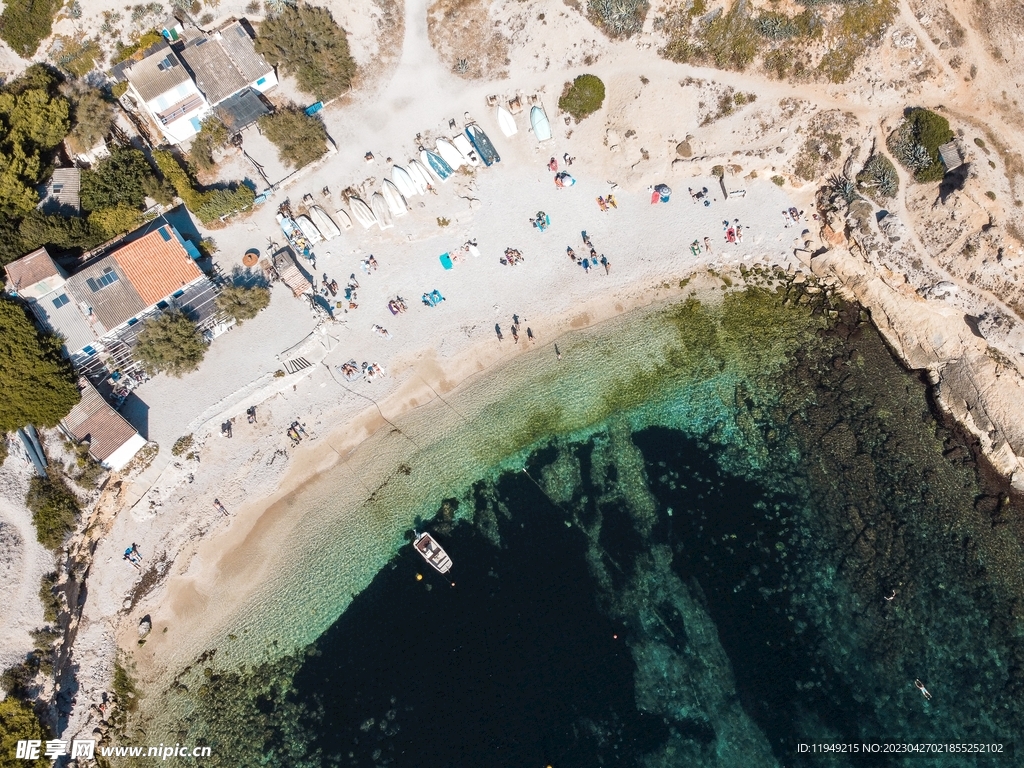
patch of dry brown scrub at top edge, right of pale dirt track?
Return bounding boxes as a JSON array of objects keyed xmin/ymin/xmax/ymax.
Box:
[{"xmin": 427, "ymin": 0, "xmax": 509, "ymax": 79}]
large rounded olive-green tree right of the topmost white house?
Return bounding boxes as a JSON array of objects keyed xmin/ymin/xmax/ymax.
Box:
[{"xmin": 256, "ymin": 5, "xmax": 356, "ymax": 101}]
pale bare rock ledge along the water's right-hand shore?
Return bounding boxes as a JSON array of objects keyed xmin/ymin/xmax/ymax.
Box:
[{"xmin": 809, "ymin": 244, "xmax": 1024, "ymax": 490}]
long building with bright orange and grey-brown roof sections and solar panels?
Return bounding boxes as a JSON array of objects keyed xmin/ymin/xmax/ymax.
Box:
[{"xmin": 5, "ymin": 222, "xmax": 217, "ymax": 366}]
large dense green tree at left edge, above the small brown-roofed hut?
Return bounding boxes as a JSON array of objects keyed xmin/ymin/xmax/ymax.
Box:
[{"xmin": 0, "ymin": 299, "xmax": 80, "ymax": 432}]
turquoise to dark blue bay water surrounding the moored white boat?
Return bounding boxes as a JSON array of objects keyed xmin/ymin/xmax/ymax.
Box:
[{"xmin": 136, "ymin": 278, "xmax": 1024, "ymax": 766}]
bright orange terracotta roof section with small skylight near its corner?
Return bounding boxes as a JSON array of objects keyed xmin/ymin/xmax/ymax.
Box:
[{"xmin": 111, "ymin": 224, "xmax": 203, "ymax": 306}]
